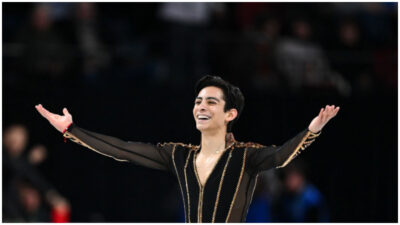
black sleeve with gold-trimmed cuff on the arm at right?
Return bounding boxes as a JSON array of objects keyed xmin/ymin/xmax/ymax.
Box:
[{"xmin": 245, "ymin": 129, "xmax": 321, "ymax": 173}]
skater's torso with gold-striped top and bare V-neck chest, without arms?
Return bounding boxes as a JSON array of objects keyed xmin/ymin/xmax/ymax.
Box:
[{"xmin": 172, "ymin": 143, "xmax": 257, "ymax": 223}]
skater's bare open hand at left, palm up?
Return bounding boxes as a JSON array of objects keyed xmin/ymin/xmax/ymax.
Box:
[{"xmin": 35, "ymin": 104, "xmax": 72, "ymax": 132}]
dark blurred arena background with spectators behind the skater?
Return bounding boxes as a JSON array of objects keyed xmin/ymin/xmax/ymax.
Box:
[{"xmin": 2, "ymin": 2, "xmax": 398, "ymax": 222}]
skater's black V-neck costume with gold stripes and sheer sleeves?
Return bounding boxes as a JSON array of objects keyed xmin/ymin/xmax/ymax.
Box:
[{"xmin": 64, "ymin": 124, "xmax": 320, "ymax": 222}]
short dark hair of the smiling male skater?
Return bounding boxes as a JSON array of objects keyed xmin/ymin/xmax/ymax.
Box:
[{"xmin": 194, "ymin": 75, "xmax": 244, "ymax": 132}]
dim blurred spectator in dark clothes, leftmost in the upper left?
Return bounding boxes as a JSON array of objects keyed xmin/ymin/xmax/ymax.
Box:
[{"xmin": 16, "ymin": 3, "xmax": 71, "ymax": 92}]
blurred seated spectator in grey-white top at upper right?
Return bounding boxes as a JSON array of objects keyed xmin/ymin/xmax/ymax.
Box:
[{"xmin": 276, "ymin": 17, "xmax": 350, "ymax": 96}]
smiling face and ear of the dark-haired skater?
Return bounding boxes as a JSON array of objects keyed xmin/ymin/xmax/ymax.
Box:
[{"xmin": 193, "ymin": 86, "xmax": 237, "ymax": 132}]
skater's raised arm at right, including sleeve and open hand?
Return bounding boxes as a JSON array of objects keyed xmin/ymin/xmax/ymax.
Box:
[{"xmin": 249, "ymin": 105, "xmax": 339, "ymax": 172}]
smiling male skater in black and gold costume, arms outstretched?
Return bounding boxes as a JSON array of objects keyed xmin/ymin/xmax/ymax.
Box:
[{"xmin": 36, "ymin": 76, "xmax": 339, "ymax": 222}]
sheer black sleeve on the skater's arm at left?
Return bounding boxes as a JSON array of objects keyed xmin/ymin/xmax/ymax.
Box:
[{"xmin": 64, "ymin": 124, "xmax": 175, "ymax": 170}]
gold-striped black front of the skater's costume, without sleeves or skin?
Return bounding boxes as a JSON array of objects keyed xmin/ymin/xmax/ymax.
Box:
[{"xmin": 173, "ymin": 146, "xmax": 246, "ymax": 222}]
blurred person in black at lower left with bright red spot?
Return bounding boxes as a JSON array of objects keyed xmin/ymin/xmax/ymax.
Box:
[{"xmin": 2, "ymin": 124, "xmax": 70, "ymax": 222}]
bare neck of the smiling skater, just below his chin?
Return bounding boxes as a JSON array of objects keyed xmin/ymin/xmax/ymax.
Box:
[{"xmin": 201, "ymin": 130, "xmax": 227, "ymax": 155}]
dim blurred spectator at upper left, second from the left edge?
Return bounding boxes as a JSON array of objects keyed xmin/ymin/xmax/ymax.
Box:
[{"xmin": 74, "ymin": 2, "xmax": 111, "ymax": 83}]
